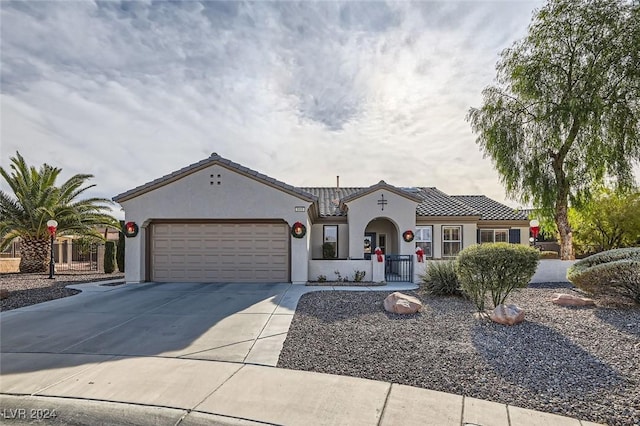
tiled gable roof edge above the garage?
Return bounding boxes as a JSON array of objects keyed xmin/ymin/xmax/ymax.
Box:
[{"xmin": 113, "ymin": 152, "xmax": 317, "ymax": 203}]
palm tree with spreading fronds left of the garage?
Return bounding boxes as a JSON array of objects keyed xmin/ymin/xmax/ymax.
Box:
[{"xmin": 0, "ymin": 152, "xmax": 119, "ymax": 272}]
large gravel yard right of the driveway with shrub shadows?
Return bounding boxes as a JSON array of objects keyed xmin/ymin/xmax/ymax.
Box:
[{"xmin": 278, "ymin": 283, "xmax": 640, "ymax": 425}]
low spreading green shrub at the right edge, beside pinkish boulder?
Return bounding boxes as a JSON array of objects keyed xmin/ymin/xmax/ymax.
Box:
[{"xmin": 567, "ymin": 247, "xmax": 640, "ymax": 303}]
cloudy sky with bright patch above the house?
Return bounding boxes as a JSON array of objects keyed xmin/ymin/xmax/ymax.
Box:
[{"xmin": 0, "ymin": 0, "xmax": 543, "ymax": 215}]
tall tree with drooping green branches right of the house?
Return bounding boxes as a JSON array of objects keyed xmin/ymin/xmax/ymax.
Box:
[{"xmin": 467, "ymin": 0, "xmax": 640, "ymax": 259}]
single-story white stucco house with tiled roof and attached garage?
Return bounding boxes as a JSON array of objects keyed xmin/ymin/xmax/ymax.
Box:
[{"xmin": 113, "ymin": 153, "xmax": 529, "ymax": 283}]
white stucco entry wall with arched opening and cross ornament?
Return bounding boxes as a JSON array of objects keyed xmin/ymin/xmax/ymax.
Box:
[{"xmin": 347, "ymin": 189, "xmax": 418, "ymax": 259}]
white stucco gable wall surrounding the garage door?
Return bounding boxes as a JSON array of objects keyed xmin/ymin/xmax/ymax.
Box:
[{"xmin": 121, "ymin": 164, "xmax": 311, "ymax": 283}]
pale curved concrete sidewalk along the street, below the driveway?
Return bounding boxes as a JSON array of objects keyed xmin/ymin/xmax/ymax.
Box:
[{"xmin": 0, "ymin": 353, "xmax": 594, "ymax": 426}]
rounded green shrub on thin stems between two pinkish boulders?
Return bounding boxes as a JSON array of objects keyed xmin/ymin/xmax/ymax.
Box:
[{"xmin": 456, "ymin": 243, "xmax": 540, "ymax": 312}]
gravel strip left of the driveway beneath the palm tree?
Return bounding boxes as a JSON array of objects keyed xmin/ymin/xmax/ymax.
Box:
[{"xmin": 0, "ymin": 272, "xmax": 124, "ymax": 311}]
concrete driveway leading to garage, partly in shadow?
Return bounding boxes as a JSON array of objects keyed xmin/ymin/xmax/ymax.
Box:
[{"xmin": 0, "ymin": 283, "xmax": 306, "ymax": 366}]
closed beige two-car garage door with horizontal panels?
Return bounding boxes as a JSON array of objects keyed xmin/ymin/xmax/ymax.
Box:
[{"xmin": 150, "ymin": 222, "xmax": 289, "ymax": 282}]
